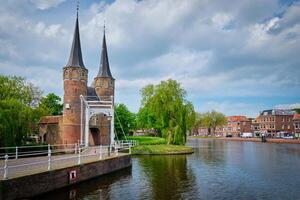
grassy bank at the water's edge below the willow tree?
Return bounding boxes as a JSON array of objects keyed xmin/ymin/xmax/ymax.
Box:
[{"xmin": 131, "ymin": 145, "xmax": 193, "ymax": 155}]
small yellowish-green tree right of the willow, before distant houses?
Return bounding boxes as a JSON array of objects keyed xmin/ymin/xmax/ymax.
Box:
[{"xmin": 195, "ymin": 110, "xmax": 227, "ymax": 135}]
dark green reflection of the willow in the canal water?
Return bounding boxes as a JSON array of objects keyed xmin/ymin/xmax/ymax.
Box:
[{"xmin": 138, "ymin": 155, "xmax": 198, "ymax": 199}]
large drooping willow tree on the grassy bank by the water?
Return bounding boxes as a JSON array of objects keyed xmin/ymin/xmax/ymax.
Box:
[{"xmin": 137, "ymin": 80, "xmax": 195, "ymax": 144}]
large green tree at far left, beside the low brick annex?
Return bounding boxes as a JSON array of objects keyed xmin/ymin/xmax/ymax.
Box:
[{"xmin": 0, "ymin": 75, "xmax": 44, "ymax": 146}]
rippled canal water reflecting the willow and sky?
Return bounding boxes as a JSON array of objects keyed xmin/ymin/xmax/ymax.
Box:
[{"xmin": 36, "ymin": 139, "xmax": 300, "ymax": 200}]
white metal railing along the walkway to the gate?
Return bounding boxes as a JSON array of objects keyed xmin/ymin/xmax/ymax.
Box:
[{"xmin": 0, "ymin": 140, "xmax": 138, "ymax": 179}]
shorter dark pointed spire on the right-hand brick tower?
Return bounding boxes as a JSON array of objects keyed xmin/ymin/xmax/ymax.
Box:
[{"xmin": 97, "ymin": 23, "xmax": 112, "ymax": 78}]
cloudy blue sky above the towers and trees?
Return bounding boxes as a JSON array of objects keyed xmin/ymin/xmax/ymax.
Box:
[{"xmin": 0, "ymin": 0, "xmax": 300, "ymax": 117}]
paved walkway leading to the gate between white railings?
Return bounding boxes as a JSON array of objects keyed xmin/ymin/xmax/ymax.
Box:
[{"xmin": 0, "ymin": 149, "xmax": 125, "ymax": 180}]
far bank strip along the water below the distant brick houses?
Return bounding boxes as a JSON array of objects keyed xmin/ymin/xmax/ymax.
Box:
[{"xmin": 189, "ymin": 136, "xmax": 300, "ymax": 144}]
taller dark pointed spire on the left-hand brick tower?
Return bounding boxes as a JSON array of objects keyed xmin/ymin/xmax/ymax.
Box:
[{"xmin": 66, "ymin": 1, "xmax": 85, "ymax": 68}]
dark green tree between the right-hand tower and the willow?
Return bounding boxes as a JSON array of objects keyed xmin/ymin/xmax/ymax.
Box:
[{"xmin": 114, "ymin": 104, "xmax": 135, "ymax": 138}]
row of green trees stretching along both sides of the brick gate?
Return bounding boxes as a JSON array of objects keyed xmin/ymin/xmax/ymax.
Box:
[{"xmin": 0, "ymin": 75, "xmax": 226, "ymax": 146}]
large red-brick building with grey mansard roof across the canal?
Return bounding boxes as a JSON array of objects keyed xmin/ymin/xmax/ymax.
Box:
[{"xmin": 259, "ymin": 109, "xmax": 295, "ymax": 137}]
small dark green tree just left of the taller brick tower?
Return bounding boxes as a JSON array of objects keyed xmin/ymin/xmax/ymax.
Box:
[{"xmin": 39, "ymin": 93, "xmax": 63, "ymax": 115}]
